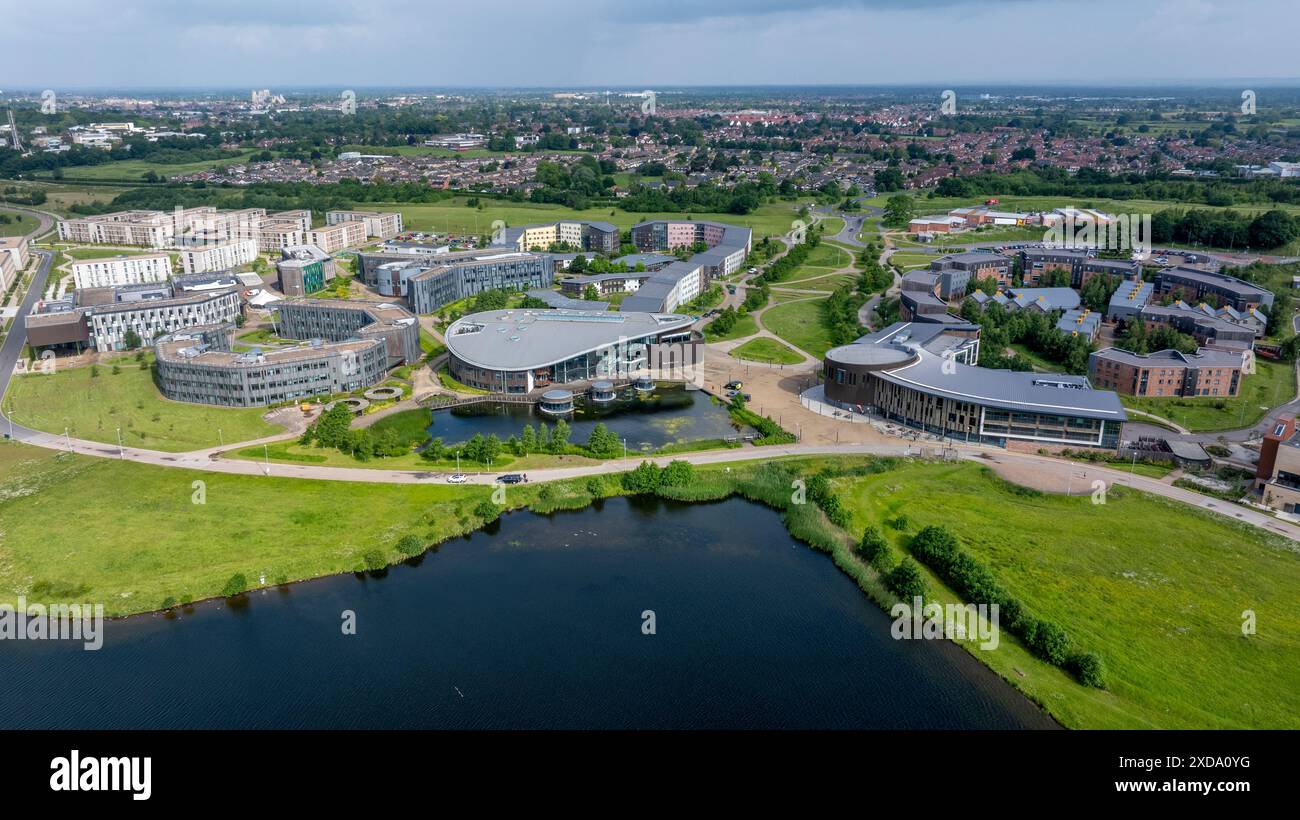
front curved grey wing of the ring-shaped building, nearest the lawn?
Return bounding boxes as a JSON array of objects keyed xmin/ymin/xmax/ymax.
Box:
[{"xmin": 153, "ymin": 325, "xmax": 389, "ymax": 407}]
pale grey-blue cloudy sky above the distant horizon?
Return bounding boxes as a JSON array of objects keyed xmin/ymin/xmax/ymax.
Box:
[{"xmin": 0, "ymin": 0, "xmax": 1300, "ymax": 88}]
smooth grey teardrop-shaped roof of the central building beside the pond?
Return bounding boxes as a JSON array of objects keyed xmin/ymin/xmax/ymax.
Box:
[{"xmin": 445, "ymin": 308, "xmax": 694, "ymax": 370}]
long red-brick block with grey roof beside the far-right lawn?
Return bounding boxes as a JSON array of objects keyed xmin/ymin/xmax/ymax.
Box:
[{"xmin": 1088, "ymin": 347, "xmax": 1245, "ymax": 398}]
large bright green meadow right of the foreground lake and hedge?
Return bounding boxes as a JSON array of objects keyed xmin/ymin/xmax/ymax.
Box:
[{"xmin": 835, "ymin": 464, "xmax": 1300, "ymax": 728}]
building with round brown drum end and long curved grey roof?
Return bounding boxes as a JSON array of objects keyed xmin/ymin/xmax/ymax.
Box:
[{"xmin": 813, "ymin": 322, "xmax": 1127, "ymax": 450}]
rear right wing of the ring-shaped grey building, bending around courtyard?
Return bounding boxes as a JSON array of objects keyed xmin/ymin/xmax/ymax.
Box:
[{"xmin": 276, "ymin": 299, "xmax": 421, "ymax": 366}]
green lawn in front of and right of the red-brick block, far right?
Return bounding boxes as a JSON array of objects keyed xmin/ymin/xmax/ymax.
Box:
[{"xmin": 1119, "ymin": 360, "xmax": 1296, "ymax": 433}]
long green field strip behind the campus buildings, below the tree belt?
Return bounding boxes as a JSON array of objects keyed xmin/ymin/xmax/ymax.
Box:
[{"xmin": 367, "ymin": 196, "xmax": 798, "ymax": 242}]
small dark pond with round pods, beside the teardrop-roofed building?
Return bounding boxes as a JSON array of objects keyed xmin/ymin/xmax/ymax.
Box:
[{"xmin": 429, "ymin": 386, "xmax": 738, "ymax": 451}]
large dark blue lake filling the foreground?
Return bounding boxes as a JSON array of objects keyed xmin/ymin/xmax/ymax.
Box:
[{"xmin": 0, "ymin": 499, "xmax": 1054, "ymax": 729}]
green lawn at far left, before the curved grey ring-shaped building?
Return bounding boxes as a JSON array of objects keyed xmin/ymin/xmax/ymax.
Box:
[{"xmin": 4, "ymin": 355, "xmax": 282, "ymax": 452}]
